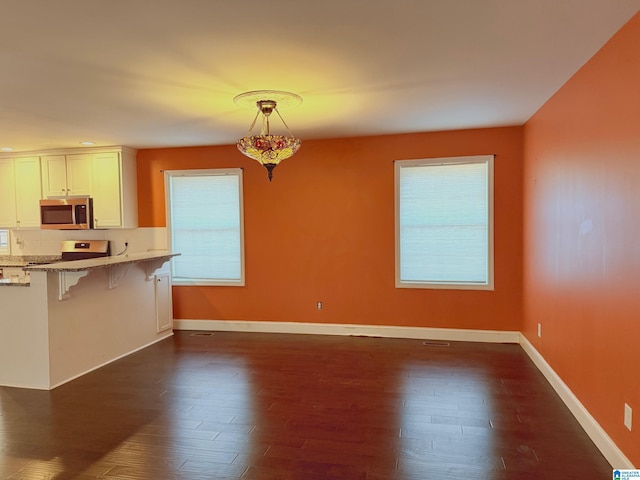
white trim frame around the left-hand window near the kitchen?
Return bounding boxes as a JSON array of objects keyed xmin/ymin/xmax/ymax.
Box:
[{"xmin": 164, "ymin": 168, "xmax": 245, "ymax": 287}]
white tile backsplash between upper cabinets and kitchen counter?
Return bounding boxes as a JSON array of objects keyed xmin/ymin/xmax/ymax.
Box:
[{"xmin": 0, "ymin": 227, "xmax": 168, "ymax": 256}]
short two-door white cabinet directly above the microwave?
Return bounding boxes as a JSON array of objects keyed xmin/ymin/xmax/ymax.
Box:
[{"xmin": 42, "ymin": 153, "xmax": 92, "ymax": 197}]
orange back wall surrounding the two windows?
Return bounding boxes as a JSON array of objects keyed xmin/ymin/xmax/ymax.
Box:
[{"xmin": 138, "ymin": 127, "xmax": 523, "ymax": 331}]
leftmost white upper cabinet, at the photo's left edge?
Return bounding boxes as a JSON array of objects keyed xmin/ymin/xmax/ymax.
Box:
[{"xmin": 0, "ymin": 157, "xmax": 42, "ymax": 228}]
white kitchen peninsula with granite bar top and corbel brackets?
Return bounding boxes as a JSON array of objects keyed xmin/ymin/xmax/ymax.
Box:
[{"xmin": 0, "ymin": 251, "xmax": 177, "ymax": 390}]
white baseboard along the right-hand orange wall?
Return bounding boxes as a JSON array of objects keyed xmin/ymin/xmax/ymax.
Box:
[{"xmin": 520, "ymin": 334, "xmax": 635, "ymax": 469}]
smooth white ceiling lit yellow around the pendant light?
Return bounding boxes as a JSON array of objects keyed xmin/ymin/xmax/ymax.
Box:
[{"xmin": 0, "ymin": 0, "xmax": 640, "ymax": 151}]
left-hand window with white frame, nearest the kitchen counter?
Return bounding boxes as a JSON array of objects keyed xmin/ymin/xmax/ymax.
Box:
[{"xmin": 165, "ymin": 169, "xmax": 244, "ymax": 286}]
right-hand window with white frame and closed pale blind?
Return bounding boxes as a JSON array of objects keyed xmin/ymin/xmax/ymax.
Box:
[{"xmin": 395, "ymin": 155, "xmax": 493, "ymax": 290}]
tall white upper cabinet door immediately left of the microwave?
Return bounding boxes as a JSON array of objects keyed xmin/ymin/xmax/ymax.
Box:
[{"xmin": 15, "ymin": 157, "xmax": 42, "ymax": 228}]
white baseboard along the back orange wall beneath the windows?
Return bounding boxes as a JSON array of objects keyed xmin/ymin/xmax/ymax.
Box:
[{"xmin": 173, "ymin": 320, "xmax": 520, "ymax": 343}]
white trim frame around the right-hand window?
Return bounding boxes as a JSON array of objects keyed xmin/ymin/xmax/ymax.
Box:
[{"xmin": 394, "ymin": 155, "xmax": 494, "ymax": 290}]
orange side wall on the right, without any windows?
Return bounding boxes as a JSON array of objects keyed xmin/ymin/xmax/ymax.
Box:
[{"xmin": 523, "ymin": 14, "xmax": 640, "ymax": 466}]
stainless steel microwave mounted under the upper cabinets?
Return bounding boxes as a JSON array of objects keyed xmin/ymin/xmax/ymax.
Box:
[{"xmin": 40, "ymin": 197, "xmax": 93, "ymax": 230}]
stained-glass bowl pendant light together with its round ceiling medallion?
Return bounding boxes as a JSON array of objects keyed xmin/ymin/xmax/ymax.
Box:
[{"xmin": 233, "ymin": 90, "xmax": 302, "ymax": 181}]
